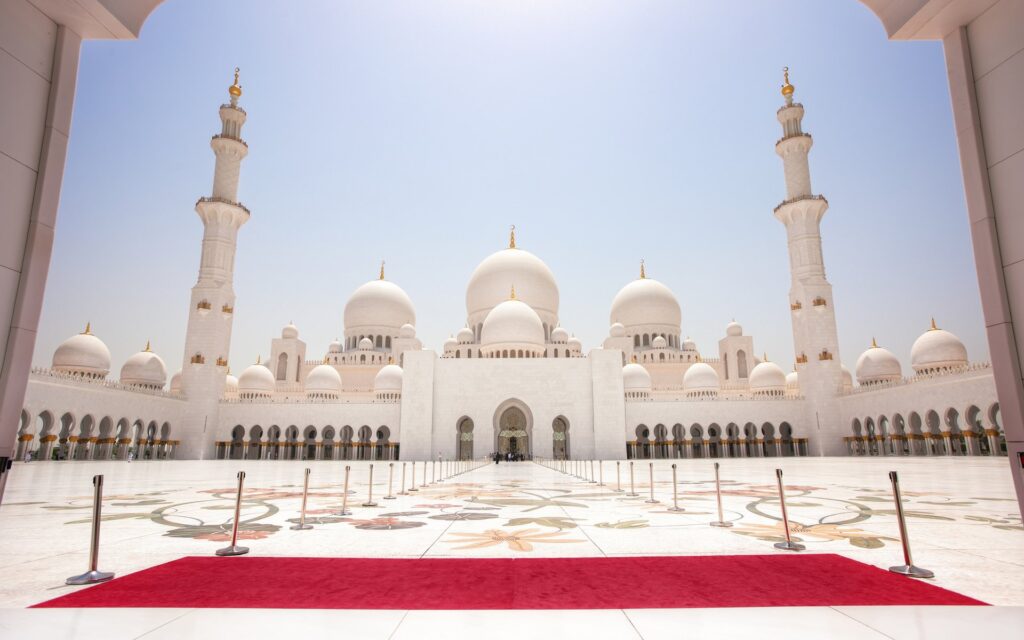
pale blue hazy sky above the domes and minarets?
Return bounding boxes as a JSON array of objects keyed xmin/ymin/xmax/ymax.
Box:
[{"xmin": 34, "ymin": 0, "xmax": 988, "ymax": 376}]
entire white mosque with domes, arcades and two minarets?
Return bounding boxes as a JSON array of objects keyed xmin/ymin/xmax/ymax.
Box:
[{"xmin": 16, "ymin": 70, "xmax": 1007, "ymax": 460}]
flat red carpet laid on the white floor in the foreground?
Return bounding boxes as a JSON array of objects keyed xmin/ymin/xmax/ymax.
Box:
[{"xmin": 36, "ymin": 554, "xmax": 984, "ymax": 609}]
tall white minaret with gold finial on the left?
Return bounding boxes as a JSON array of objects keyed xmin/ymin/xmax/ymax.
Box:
[{"xmin": 180, "ymin": 69, "xmax": 249, "ymax": 459}]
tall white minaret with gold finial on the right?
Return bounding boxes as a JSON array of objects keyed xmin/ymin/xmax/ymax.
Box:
[{"xmin": 775, "ymin": 67, "xmax": 843, "ymax": 455}]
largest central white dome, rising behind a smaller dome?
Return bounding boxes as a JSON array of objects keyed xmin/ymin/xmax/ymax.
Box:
[{"xmin": 466, "ymin": 244, "xmax": 558, "ymax": 326}]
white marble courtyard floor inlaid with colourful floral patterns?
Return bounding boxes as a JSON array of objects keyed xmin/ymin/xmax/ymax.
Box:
[{"xmin": 0, "ymin": 458, "xmax": 1024, "ymax": 639}]
